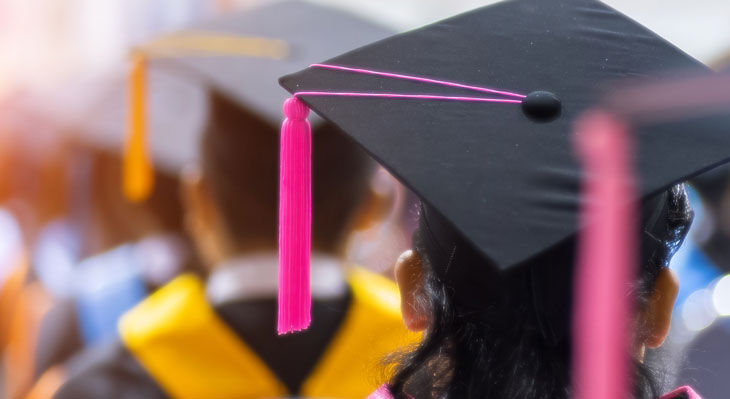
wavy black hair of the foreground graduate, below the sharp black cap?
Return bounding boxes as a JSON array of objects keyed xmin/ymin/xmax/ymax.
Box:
[{"xmin": 390, "ymin": 186, "xmax": 692, "ymax": 399}]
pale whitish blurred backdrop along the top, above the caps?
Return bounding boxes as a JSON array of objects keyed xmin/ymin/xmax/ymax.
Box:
[{"xmin": 0, "ymin": 0, "xmax": 730, "ymax": 95}]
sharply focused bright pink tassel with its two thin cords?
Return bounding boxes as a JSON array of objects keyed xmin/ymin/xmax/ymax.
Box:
[{"xmin": 277, "ymin": 64, "xmax": 525, "ymax": 334}]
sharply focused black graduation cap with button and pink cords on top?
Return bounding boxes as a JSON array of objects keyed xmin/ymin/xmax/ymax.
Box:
[{"xmin": 280, "ymin": 0, "xmax": 730, "ymax": 276}]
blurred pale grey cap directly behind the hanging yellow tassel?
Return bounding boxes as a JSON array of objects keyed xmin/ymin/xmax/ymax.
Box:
[{"xmin": 56, "ymin": 70, "xmax": 209, "ymax": 176}]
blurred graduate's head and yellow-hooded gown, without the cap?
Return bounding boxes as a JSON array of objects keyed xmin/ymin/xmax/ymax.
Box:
[{"xmin": 56, "ymin": 95, "xmax": 415, "ymax": 398}]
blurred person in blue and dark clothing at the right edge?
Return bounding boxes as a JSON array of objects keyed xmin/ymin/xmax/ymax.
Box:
[{"xmin": 652, "ymin": 54, "xmax": 730, "ymax": 399}]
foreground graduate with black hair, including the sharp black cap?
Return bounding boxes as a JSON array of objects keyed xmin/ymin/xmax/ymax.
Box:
[{"xmin": 280, "ymin": 0, "xmax": 729, "ymax": 399}]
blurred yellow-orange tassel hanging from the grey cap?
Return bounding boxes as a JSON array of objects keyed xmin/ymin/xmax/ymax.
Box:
[{"xmin": 122, "ymin": 52, "xmax": 154, "ymax": 202}]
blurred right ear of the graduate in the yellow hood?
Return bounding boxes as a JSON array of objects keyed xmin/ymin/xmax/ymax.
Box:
[{"xmin": 353, "ymin": 169, "xmax": 396, "ymax": 231}]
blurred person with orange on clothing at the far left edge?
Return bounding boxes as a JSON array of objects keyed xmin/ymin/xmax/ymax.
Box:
[{"xmin": 0, "ymin": 91, "xmax": 77, "ymax": 398}]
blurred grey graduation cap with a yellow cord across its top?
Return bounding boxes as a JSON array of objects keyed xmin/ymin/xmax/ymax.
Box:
[{"xmin": 143, "ymin": 1, "xmax": 392, "ymax": 126}]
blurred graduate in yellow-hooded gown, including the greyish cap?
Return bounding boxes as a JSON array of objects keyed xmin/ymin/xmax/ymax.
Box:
[{"xmin": 55, "ymin": 2, "xmax": 418, "ymax": 398}]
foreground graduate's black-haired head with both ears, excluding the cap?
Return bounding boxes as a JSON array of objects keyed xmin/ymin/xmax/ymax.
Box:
[{"xmin": 382, "ymin": 186, "xmax": 692, "ymax": 399}]
